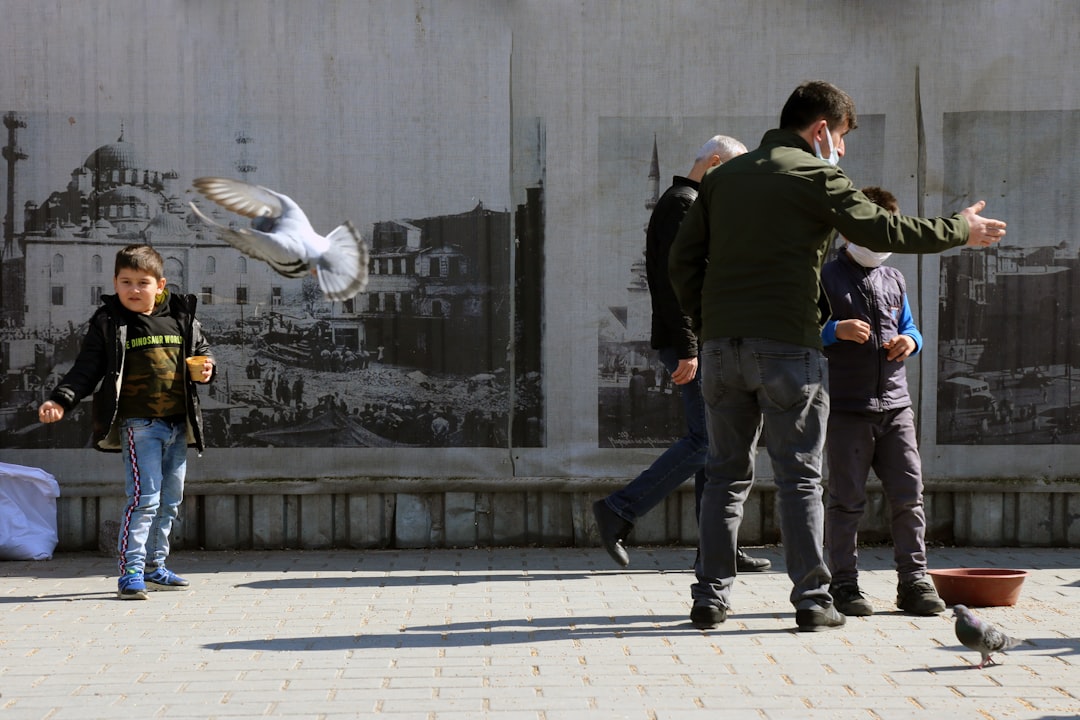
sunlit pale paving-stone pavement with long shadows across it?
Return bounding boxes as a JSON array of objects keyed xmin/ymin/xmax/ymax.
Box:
[{"xmin": 0, "ymin": 547, "xmax": 1080, "ymax": 720}]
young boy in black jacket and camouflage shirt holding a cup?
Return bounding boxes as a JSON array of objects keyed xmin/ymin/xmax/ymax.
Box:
[{"xmin": 38, "ymin": 245, "xmax": 214, "ymax": 600}]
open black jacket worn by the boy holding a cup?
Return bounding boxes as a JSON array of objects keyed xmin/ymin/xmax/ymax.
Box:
[{"xmin": 49, "ymin": 293, "xmax": 217, "ymax": 452}]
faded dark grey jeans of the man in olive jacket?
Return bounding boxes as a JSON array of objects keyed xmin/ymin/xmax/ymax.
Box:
[{"xmin": 691, "ymin": 338, "xmax": 833, "ymax": 610}]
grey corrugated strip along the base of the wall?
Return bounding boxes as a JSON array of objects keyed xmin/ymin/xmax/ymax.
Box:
[{"xmin": 57, "ymin": 478, "xmax": 1080, "ymax": 552}]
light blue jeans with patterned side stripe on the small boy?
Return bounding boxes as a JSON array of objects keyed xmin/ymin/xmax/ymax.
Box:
[{"xmin": 118, "ymin": 418, "xmax": 188, "ymax": 575}]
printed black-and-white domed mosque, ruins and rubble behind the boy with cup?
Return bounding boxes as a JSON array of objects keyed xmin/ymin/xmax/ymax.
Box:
[{"xmin": 0, "ymin": 113, "xmax": 543, "ymax": 447}]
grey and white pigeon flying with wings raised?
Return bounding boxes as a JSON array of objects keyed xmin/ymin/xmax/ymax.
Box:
[{"xmin": 190, "ymin": 177, "xmax": 367, "ymax": 301}]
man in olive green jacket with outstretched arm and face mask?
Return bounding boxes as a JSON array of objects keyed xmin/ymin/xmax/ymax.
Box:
[{"xmin": 669, "ymin": 81, "xmax": 1005, "ymax": 630}]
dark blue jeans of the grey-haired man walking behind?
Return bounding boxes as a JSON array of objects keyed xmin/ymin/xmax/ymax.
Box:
[{"xmin": 605, "ymin": 348, "xmax": 708, "ymax": 522}]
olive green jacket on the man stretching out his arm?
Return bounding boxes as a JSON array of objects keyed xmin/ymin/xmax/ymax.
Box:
[{"xmin": 669, "ymin": 130, "xmax": 969, "ymax": 349}]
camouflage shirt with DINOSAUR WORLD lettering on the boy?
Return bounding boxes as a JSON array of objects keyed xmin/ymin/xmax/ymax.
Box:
[{"xmin": 119, "ymin": 302, "xmax": 187, "ymax": 418}]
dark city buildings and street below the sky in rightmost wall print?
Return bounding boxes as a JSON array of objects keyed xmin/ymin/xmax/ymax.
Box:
[{"xmin": 937, "ymin": 244, "xmax": 1080, "ymax": 445}]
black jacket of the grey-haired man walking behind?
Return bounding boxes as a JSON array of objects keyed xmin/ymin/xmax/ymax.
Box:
[{"xmin": 645, "ymin": 175, "xmax": 698, "ymax": 359}]
